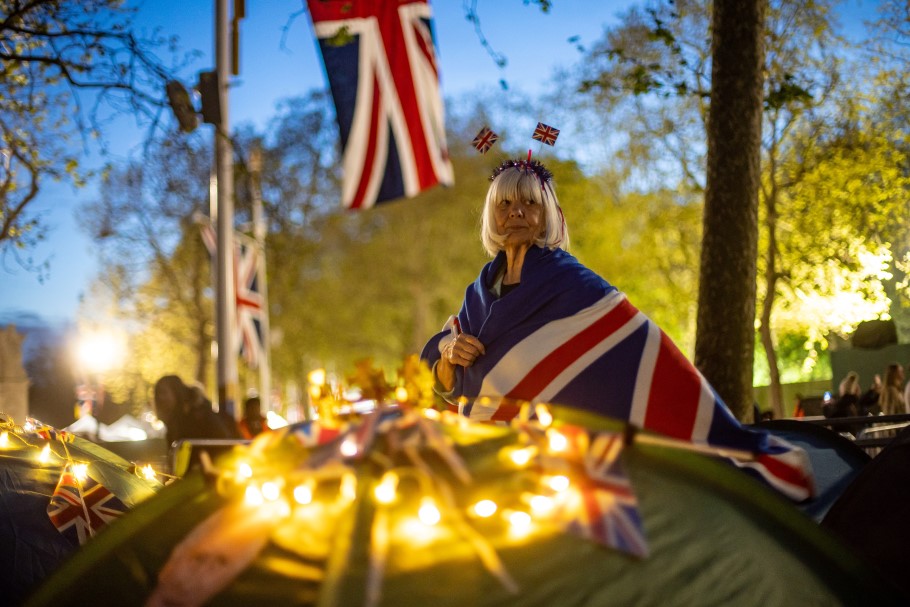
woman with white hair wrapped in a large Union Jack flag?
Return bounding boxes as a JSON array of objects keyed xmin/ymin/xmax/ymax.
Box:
[{"xmin": 421, "ymin": 159, "xmax": 813, "ymax": 500}]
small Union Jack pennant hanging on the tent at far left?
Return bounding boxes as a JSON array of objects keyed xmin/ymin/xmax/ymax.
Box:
[{"xmin": 47, "ymin": 464, "xmax": 127, "ymax": 545}]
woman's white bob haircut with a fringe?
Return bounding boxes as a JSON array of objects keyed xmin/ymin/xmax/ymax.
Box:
[{"xmin": 480, "ymin": 162, "xmax": 569, "ymax": 257}]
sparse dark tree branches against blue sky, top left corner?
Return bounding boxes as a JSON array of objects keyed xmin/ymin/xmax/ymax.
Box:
[{"xmin": 0, "ymin": 0, "xmax": 182, "ymax": 270}]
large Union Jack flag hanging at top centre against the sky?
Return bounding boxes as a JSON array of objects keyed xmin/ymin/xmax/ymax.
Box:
[{"xmin": 307, "ymin": 0, "xmax": 453, "ymax": 209}]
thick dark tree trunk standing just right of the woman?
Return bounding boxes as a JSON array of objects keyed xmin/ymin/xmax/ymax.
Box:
[{"xmin": 695, "ymin": 0, "xmax": 767, "ymax": 419}]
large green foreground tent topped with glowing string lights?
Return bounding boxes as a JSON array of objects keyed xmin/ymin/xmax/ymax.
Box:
[{"xmin": 27, "ymin": 409, "xmax": 906, "ymax": 607}]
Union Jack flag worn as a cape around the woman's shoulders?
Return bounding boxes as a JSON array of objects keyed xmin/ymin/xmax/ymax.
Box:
[{"xmin": 421, "ymin": 246, "xmax": 814, "ymax": 500}]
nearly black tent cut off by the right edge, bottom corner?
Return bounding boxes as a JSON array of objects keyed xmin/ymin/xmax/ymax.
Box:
[{"xmin": 821, "ymin": 427, "xmax": 910, "ymax": 604}]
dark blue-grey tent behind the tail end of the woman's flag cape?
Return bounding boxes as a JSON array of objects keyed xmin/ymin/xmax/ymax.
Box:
[{"xmin": 757, "ymin": 419, "xmax": 871, "ymax": 522}]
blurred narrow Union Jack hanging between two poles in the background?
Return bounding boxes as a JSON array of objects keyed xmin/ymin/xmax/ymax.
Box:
[{"xmin": 234, "ymin": 238, "xmax": 265, "ymax": 369}]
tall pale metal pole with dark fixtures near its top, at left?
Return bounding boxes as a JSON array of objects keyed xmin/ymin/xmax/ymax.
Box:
[{"xmin": 215, "ymin": 0, "xmax": 237, "ymax": 416}]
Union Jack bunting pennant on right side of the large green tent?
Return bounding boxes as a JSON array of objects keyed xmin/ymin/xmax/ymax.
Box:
[{"xmin": 559, "ymin": 426, "xmax": 648, "ymax": 557}]
